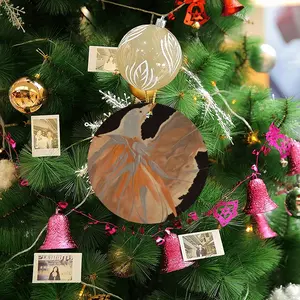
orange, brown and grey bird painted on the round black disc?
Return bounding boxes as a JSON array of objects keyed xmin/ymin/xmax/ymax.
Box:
[{"xmin": 89, "ymin": 105, "xmax": 206, "ymax": 224}]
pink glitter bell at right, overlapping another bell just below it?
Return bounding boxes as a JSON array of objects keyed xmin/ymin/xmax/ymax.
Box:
[{"xmin": 244, "ymin": 178, "xmax": 277, "ymax": 215}]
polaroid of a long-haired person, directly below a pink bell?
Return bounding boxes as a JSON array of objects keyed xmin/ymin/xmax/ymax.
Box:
[{"xmin": 32, "ymin": 253, "xmax": 82, "ymax": 283}]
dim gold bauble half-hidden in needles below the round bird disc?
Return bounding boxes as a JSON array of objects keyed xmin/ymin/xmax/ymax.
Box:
[{"xmin": 109, "ymin": 248, "xmax": 133, "ymax": 278}]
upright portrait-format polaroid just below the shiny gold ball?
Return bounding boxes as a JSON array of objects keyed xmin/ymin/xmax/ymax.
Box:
[{"xmin": 31, "ymin": 115, "xmax": 60, "ymax": 157}]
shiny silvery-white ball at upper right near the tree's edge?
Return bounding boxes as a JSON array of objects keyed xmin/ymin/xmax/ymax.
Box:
[{"xmin": 251, "ymin": 44, "xmax": 277, "ymax": 73}]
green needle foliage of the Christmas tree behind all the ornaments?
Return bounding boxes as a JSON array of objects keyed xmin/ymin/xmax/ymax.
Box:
[{"xmin": 0, "ymin": 0, "xmax": 300, "ymax": 300}]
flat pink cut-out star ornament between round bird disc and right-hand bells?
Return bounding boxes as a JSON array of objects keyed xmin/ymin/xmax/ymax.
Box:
[{"xmin": 208, "ymin": 200, "xmax": 239, "ymax": 227}]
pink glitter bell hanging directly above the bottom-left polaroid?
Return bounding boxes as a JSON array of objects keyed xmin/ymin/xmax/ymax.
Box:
[{"xmin": 39, "ymin": 204, "xmax": 77, "ymax": 250}]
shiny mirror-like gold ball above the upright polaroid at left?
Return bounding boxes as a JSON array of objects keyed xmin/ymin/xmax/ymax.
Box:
[{"xmin": 9, "ymin": 77, "xmax": 47, "ymax": 114}]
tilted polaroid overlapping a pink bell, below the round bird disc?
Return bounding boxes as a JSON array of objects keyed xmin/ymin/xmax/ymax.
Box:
[{"xmin": 178, "ymin": 229, "xmax": 225, "ymax": 261}]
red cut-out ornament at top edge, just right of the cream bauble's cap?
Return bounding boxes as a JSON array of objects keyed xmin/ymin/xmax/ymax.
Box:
[{"xmin": 168, "ymin": 0, "xmax": 210, "ymax": 25}]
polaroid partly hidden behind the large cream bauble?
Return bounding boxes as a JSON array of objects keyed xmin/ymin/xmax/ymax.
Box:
[{"xmin": 88, "ymin": 46, "xmax": 118, "ymax": 72}]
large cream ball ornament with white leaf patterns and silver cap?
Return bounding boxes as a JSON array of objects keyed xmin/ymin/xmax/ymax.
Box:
[{"xmin": 116, "ymin": 19, "xmax": 182, "ymax": 91}]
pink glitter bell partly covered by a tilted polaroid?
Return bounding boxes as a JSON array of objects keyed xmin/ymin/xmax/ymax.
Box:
[{"xmin": 161, "ymin": 232, "xmax": 194, "ymax": 273}]
